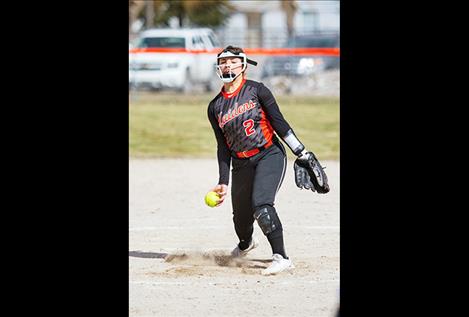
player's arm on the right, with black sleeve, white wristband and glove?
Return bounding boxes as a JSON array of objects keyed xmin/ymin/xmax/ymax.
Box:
[{"xmin": 258, "ymin": 84, "xmax": 329, "ymax": 194}]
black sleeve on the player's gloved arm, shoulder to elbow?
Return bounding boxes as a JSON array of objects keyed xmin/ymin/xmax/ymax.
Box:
[{"xmin": 257, "ymin": 84, "xmax": 291, "ymax": 138}]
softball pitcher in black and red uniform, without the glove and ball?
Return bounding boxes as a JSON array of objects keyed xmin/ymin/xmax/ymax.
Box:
[{"xmin": 208, "ymin": 46, "xmax": 320, "ymax": 275}]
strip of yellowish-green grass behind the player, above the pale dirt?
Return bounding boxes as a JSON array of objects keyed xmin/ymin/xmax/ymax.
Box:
[{"xmin": 129, "ymin": 92, "xmax": 339, "ymax": 160}]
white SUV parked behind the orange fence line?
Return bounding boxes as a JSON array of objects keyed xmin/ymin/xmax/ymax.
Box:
[{"xmin": 129, "ymin": 28, "xmax": 221, "ymax": 92}]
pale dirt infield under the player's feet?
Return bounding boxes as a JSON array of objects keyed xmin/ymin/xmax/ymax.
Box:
[{"xmin": 129, "ymin": 159, "xmax": 340, "ymax": 317}]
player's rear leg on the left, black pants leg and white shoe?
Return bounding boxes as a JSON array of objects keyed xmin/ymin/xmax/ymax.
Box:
[{"xmin": 231, "ymin": 158, "xmax": 257, "ymax": 256}]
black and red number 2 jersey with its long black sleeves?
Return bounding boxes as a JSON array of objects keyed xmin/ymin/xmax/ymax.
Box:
[{"xmin": 208, "ymin": 79, "xmax": 291, "ymax": 184}]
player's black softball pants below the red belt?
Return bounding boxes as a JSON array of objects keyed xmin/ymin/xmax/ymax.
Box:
[{"xmin": 231, "ymin": 141, "xmax": 287, "ymax": 249}]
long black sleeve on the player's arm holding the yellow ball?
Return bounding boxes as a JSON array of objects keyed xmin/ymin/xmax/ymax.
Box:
[{"xmin": 207, "ymin": 104, "xmax": 231, "ymax": 185}]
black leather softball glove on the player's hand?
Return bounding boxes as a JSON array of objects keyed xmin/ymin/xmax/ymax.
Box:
[{"xmin": 293, "ymin": 151, "xmax": 329, "ymax": 194}]
